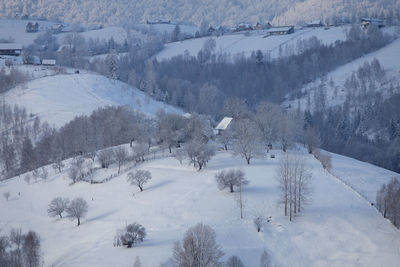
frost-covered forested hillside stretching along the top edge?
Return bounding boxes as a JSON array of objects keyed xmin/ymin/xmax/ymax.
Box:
[{"xmin": 0, "ymin": 0, "xmax": 400, "ymax": 25}]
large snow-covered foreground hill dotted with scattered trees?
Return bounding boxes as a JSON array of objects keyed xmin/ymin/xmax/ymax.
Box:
[{"xmin": 0, "ymin": 151, "xmax": 400, "ymax": 267}]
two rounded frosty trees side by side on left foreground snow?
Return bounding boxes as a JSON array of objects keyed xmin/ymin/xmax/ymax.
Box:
[{"xmin": 47, "ymin": 197, "xmax": 89, "ymax": 226}]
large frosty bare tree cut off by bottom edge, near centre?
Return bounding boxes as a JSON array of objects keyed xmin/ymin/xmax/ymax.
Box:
[{"xmin": 173, "ymin": 223, "xmax": 224, "ymax": 267}]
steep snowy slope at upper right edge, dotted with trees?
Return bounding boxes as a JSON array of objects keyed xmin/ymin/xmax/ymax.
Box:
[{"xmin": 284, "ymin": 35, "xmax": 400, "ymax": 109}]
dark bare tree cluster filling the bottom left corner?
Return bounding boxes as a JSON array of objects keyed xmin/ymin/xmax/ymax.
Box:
[{"xmin": 0, "ymin": 229, "xmax": 43, "ymax": 267}]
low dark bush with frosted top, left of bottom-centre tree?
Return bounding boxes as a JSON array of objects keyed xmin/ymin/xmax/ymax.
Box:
[{"xmin": 114, "ymin": 223, "xmax": 146, "ymax": 248}]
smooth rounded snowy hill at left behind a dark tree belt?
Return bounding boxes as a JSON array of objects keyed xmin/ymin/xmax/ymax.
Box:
[{"xmin": 4, "ymin": 74, "xmax": 181, "ymax": 126}]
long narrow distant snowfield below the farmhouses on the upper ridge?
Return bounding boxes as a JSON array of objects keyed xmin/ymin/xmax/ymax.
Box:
[{"xmin": 156, "ymin": 26, "xmax": 348, "ymax": 60}]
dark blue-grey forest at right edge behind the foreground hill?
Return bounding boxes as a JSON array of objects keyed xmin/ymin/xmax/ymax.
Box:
[{"xmin": 305, "ymin": 94, "xmax": 400, "ymax": 172}]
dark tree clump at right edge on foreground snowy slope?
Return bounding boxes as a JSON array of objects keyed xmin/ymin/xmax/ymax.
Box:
[{"xmin": 376, "ymin": 177, "xmax": 400, "ymax": 228}]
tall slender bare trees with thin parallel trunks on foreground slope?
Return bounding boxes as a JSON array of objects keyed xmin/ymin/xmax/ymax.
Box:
[{"xmin": 276, "ymin": 154, "xmax": 312, "ymax": 221}]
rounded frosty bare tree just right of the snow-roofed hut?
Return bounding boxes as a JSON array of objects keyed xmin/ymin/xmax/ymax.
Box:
[{"xmin": 233, "ymin": 119, "xmax": 262, "ymax": 164}]
